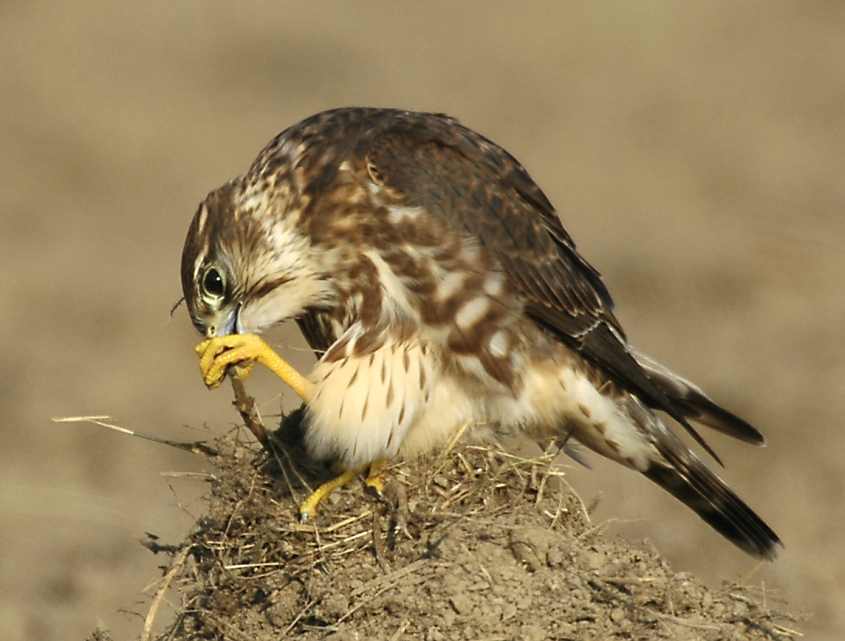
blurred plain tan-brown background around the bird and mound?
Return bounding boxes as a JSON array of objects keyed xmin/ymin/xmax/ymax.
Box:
[{"xmin": 0, "ymin": 1, "xmax": 845, "ymax": 641}]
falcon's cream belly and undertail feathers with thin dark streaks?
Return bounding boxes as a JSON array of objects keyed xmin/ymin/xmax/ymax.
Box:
[{"xmin": 306, "ymin": 330, "xmax": 655, "ymax": 471}]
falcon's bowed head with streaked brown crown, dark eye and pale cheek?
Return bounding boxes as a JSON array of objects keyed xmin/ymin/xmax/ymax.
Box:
[{"xmin": 182, "ymin": 181, "xmax": 332, "ymax": 337}]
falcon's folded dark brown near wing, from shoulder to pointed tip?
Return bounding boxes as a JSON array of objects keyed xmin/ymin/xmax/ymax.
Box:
[{"xmin": 357, "ymin": 112, "xmax": 721, "ymax": 463}]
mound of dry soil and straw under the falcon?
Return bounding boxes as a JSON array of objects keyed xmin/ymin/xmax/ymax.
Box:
[{"xmin": 132, "ymin": 410, "xmax": 798, "ymax": 641}]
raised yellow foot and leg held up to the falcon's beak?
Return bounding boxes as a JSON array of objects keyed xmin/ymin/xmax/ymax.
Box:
[{"xmin": 194, "ymin": 334, "xmax": 314, "ymax": 403}]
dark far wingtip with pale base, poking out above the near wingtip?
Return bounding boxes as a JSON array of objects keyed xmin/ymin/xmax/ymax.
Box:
[{"xmin": 631, "ymin": 350, "xmax": 766, "ymax": 445}]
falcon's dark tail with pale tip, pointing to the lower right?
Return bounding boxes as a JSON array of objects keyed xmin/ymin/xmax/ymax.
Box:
[{"xmin": 627, "ymin": 398, "xmax": 783, "ymax": 560}]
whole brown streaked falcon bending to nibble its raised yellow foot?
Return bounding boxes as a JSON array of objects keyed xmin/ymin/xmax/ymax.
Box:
[{"xmin": 182, "ymin": 108, "xmax": 780, "ymax": 559}]
